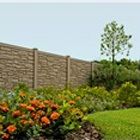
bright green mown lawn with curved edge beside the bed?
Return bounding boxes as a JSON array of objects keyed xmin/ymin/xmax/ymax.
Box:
[{"xmin": 86, "ymin": 108, "xmax": 140, "ymax": 140}]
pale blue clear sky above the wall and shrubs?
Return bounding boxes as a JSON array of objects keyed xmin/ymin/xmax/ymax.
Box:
[{"xmin": 0, "ymin": 3, "xmax": 140, "ymax": 61}]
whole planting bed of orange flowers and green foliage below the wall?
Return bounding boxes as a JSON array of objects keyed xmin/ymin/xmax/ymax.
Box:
[{"xmin": 0, "ymin": 83, "xmax": 140, "ymax": 140}]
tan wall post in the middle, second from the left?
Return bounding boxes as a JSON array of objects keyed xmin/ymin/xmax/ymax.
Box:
[{"xmin": 66, "ymin": 56, "xmax": 70, "ymax": 88}]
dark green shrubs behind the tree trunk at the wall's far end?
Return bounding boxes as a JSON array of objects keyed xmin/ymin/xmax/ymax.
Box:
[{"xmin": 92, "ymin": 59, "xmax": 140, "ymax": 90}]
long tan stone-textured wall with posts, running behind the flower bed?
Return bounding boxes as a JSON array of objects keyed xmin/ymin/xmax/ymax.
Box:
[{"xmin": 0, "ymin": 43, "xmax": 92, "ymax": 89}]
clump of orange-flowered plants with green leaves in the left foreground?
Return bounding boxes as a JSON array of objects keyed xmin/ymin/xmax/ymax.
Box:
[{"xmin": 0, "ymin": 84, "xmax": 83, "ymax": 140}]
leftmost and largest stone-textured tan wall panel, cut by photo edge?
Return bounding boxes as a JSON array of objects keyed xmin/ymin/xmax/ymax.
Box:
[{"xmin": 0, "ymin": 44, "xmax": 34, "ymax": 89}]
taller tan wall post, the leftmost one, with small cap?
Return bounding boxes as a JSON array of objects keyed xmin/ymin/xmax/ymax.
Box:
[{"xmin": 33, "ymin": 48, "xmax": 38, "ymax": 89}]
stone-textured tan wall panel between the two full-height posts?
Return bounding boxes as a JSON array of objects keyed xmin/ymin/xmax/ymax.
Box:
[{"xmin": 38, "ymin": 51, "xmax": 67, "ymax": 87}]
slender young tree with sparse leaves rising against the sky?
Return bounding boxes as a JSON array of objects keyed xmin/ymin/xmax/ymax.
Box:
[{"xmin": 100, "ymin": 21, "xmax": 132, "ymax": 87}]
